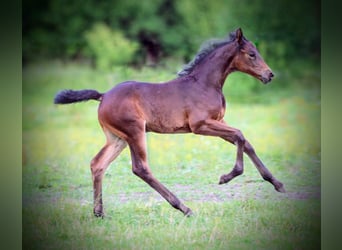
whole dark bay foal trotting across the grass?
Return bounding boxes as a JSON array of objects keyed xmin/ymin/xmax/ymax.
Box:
[{"xmin": 54, "ymin": 28, "xmax": 285, "ymax": 217}]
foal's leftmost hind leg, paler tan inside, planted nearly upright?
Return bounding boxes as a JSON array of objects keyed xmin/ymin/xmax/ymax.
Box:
[{"xmin": 90, "ymin": 132, "xmax": 127, "ymax": 217}]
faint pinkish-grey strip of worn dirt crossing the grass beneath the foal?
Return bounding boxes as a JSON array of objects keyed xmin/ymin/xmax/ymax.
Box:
[{"xmin": 23, "ymin": 180, "xmax": 321, "ymax": 206}]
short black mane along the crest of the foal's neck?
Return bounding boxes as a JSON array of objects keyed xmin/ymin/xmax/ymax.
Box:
[{"xmin": 177, "ymin": 32, "xmax": 235, "ymax": 76}]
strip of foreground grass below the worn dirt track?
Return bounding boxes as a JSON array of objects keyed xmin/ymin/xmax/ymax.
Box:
[{"xmin": 23, "ymin": 199, "xmax": 320, "ymax": 249}]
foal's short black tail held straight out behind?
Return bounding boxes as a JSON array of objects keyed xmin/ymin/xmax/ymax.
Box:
[{"xmin": 54, "ymin": 89, "xmax": 103, "ymax": 104}]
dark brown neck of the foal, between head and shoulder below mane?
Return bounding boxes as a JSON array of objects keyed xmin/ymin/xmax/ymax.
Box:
[{"xmin": 193, "ymin": 42, "xmax": 238, "ymax": 89}]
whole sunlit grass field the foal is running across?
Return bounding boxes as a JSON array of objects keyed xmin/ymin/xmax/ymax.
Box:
[{"xmin": 23, "ymin": 62, "xmax": 321, "ymax": 249}]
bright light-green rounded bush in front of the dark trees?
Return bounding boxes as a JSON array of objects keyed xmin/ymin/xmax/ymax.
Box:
[{"xmin": 85, "ymin": 23, "xmax": 138, "ymax": 71}]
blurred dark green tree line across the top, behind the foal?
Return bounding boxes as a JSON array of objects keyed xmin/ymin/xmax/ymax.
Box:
[{"xmin": 23, "ymin": 0, "xmax": 320, "ymax": 67}]
